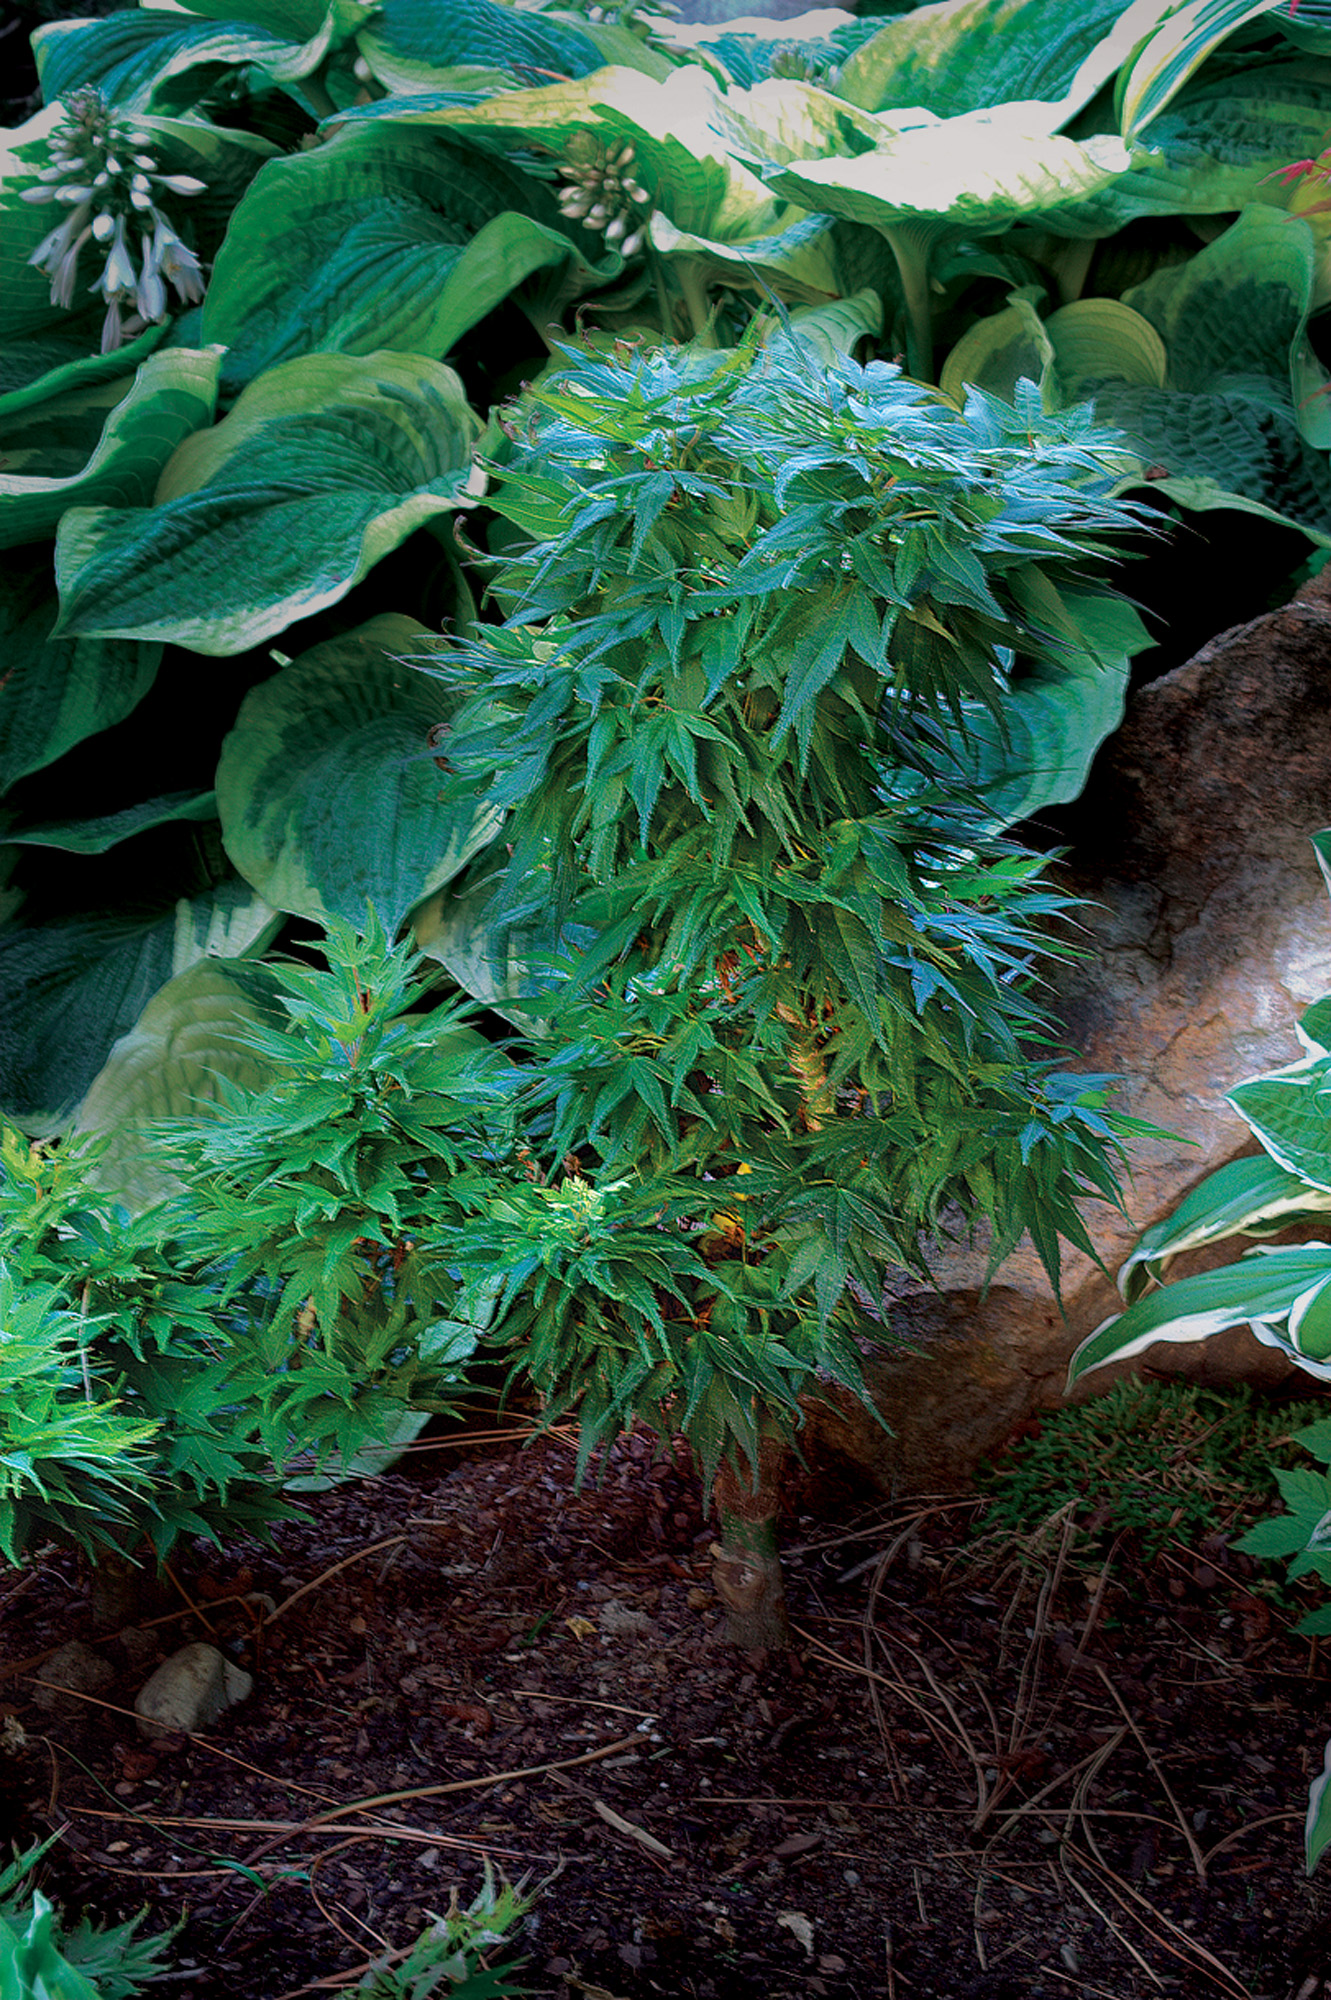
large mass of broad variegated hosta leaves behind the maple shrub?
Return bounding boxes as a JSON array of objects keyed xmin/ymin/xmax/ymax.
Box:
[{"xmin": 0, "ymin": 0, "xmax": 1331, "ymax": 1140}]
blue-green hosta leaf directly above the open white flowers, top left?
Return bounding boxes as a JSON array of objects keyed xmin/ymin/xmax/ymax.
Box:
[{"xmin": 32, "ymin": 0, "xmax": 374, "ymax": 112}]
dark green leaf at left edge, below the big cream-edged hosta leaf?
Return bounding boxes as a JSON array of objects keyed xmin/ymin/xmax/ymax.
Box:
[{"xmin": 0, "ymin": 548, "xmax": 162, "ymax": 794}]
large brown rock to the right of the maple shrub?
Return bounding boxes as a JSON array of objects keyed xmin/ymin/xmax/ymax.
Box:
[{"xmin": 811, "ymin": 576, "xmax": 1331, "ymax": 1492}]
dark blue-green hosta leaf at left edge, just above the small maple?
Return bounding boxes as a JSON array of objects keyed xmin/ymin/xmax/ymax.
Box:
[{"xmin": 0, "ymin": 854, "xmax": 280, "ymax": 1132}]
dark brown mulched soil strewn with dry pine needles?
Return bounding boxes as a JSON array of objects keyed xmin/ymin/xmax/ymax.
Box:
[{"xmin": 0, "ymin": 1436, "xmax": 1331, "ymax": 2000}]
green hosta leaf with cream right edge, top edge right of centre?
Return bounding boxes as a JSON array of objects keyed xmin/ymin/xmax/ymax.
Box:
[{"xmin": 835, "ymin": 0, "xmax": 1175, "ymax": 124}]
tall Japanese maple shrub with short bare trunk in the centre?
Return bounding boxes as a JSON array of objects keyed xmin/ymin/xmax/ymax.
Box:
[{"xmin": 422, "ymin": 330, "xmax": 1133, "ymax": 1646}]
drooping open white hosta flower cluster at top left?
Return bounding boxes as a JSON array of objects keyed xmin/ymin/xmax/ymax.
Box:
[{"xmin": 24, "ymin": 84, "xmax": 204, "ymax": 354}]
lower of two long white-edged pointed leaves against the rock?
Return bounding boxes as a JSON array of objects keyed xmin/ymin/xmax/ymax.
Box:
[{"xmin": 1067, "ymin": 1242, "xmax": 1331, "ymax": 1388}]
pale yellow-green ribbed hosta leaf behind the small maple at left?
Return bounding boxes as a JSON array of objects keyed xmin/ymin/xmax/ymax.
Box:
[{"xmin": 74, "ymin": 956, "xmax": 286, "ymax": 1210}]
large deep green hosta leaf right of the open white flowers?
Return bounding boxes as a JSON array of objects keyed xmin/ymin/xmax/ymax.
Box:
[{"xmin": 204, "ymin": 124, "xmax": 622, "ymax": 384}]
